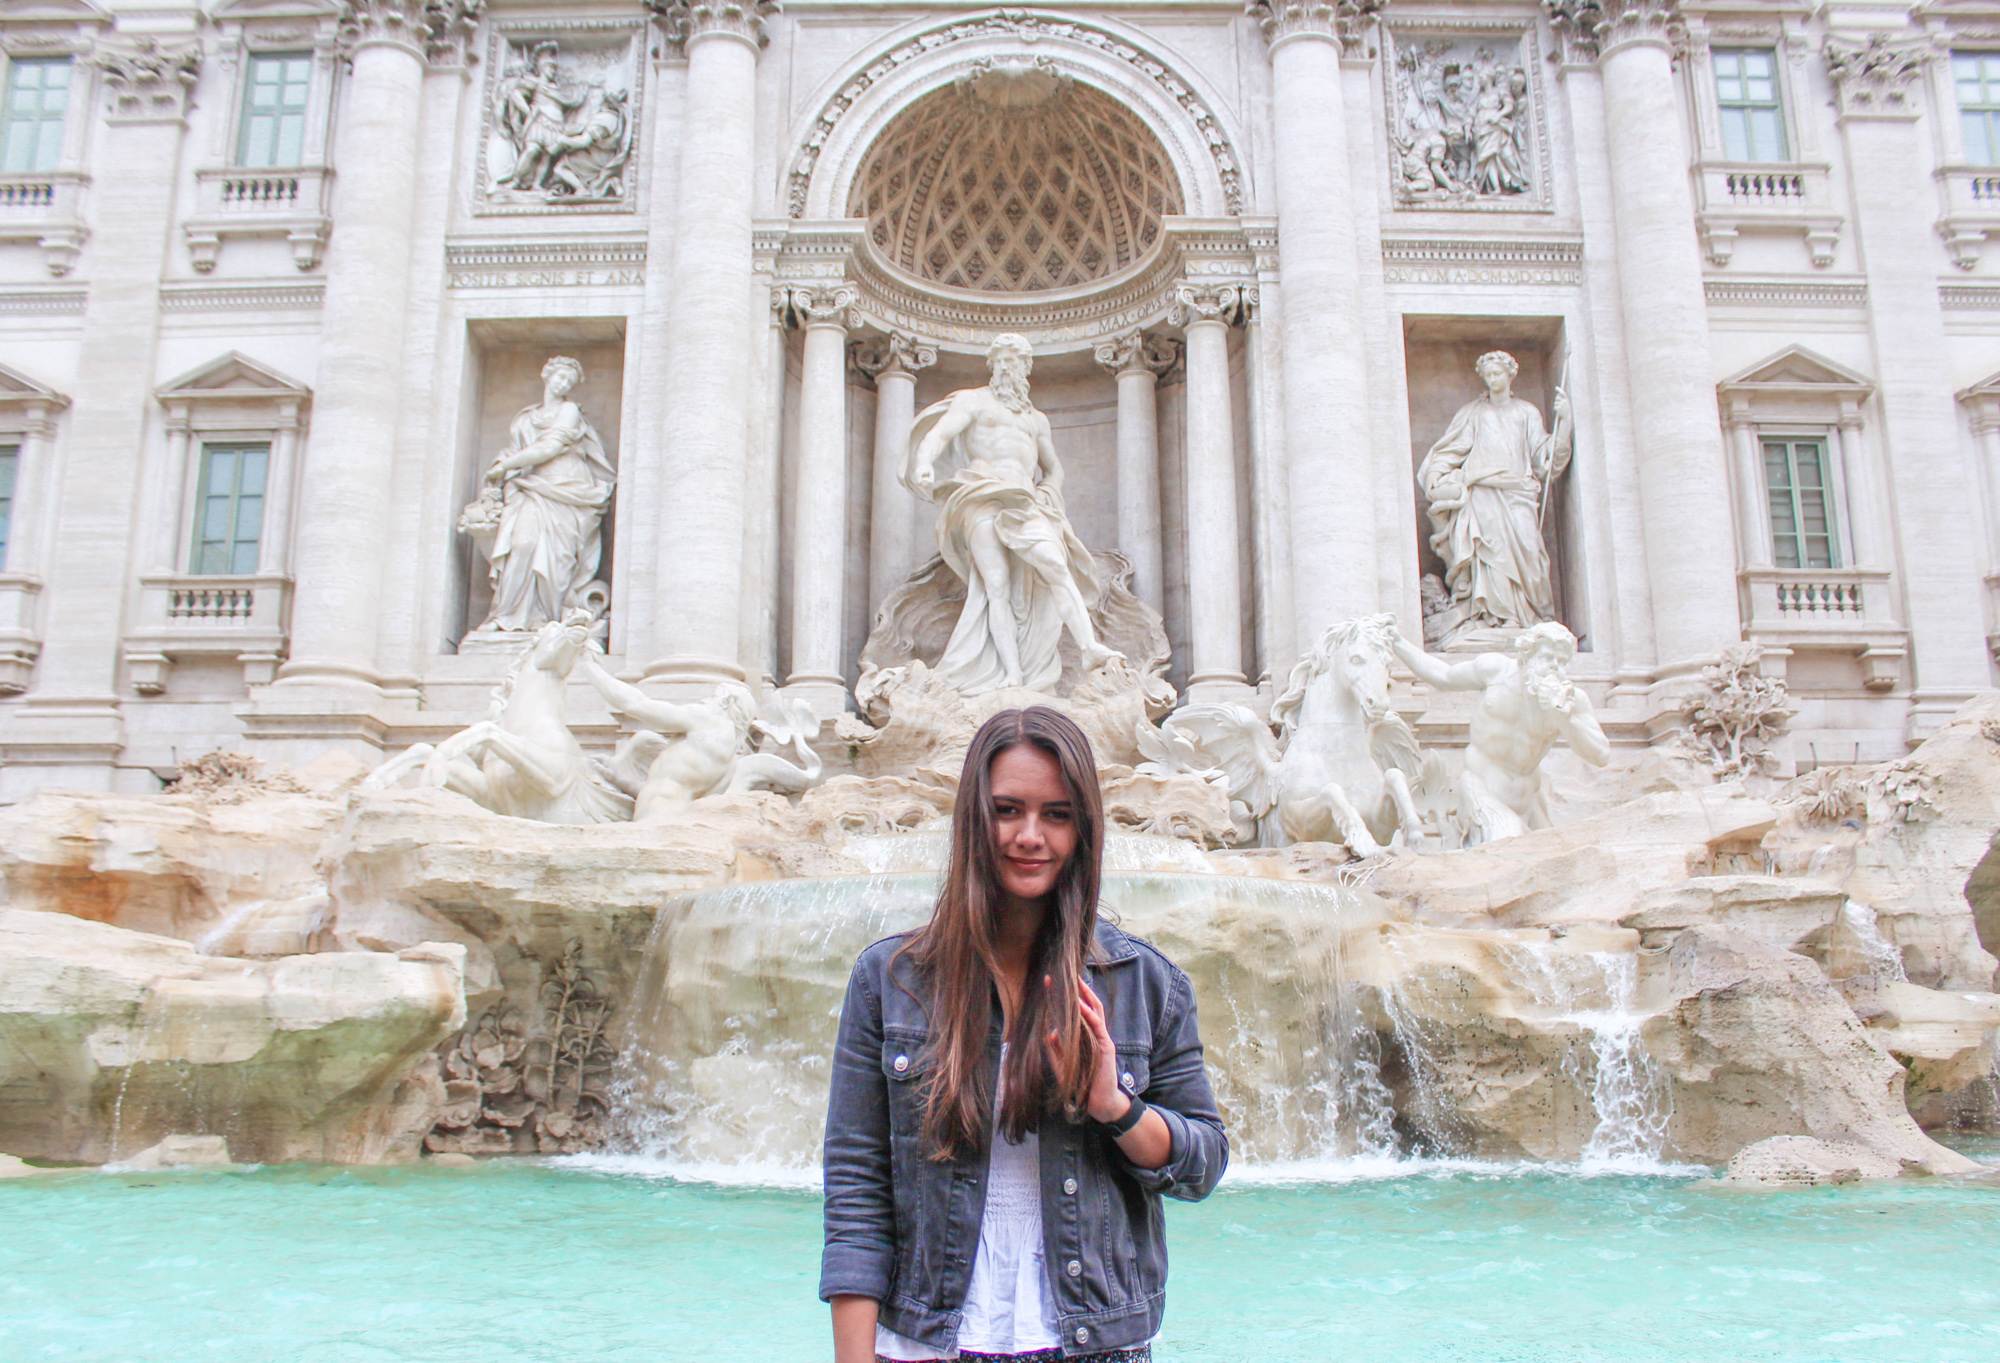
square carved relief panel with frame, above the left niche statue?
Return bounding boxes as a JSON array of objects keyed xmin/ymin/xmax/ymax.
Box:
[{"xmin": 472, "ymin": 20, "xmax": 644, "ymax": 214}]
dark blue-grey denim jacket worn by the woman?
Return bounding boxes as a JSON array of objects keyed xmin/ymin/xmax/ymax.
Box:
[{"xmin": 820, "ymin": 919, "xmax": 1230, "ymax": 1353}]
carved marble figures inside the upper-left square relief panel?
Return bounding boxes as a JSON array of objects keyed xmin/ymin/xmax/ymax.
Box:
[{"xmin": 494, "ymin": 42, "xmax": 632, "ymax": 202}]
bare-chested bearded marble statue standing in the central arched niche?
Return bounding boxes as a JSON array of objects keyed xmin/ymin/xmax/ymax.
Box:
[{"xmin": 902, "ymin": 336, "xmax": 1118, "ymax": 695}]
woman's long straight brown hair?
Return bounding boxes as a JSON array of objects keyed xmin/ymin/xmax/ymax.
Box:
[{"xmin": 890, "ymin": 705, "xmax": 1104, "ymax": 1159}]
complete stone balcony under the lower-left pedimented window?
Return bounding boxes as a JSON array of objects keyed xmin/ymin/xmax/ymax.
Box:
[{"xmin": 124, "ymin": 574, "xmax": 292, "ymax": 695}]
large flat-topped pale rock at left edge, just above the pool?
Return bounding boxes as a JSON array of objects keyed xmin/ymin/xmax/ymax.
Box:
[{"xmin": 0, "ymin": 909, "xmax": 466, "ymax": 1163}]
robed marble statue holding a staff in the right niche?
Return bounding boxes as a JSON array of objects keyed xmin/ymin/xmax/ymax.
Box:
[{"xmin": 1416, "ymin": 350, "xmax": 1574, "ymax": 640}]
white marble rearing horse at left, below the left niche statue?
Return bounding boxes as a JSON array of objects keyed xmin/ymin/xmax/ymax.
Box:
[{"xmin": 366, "ymin": 610, "xmax": 632, "ymax": 823}]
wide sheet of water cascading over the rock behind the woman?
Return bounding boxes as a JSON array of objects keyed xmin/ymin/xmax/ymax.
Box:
[{"xmin": 596, "ymin": 839, "xmax": 1394, "ymax": 1181}]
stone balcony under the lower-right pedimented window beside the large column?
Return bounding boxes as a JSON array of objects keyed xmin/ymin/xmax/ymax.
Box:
[{"xmin": 1738, "ymin": 568, "xmax": 1910, "ymax": 691}]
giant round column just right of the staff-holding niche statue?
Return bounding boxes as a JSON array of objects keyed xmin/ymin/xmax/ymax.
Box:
[{"xmin": 1548, "ymin": 0, "xmax": 1742, "ymax": 680}]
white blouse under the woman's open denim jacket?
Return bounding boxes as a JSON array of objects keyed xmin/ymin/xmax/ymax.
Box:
[{"xmin": 876, "ymin": 1043, "xmax": 1060, "ymax": 1359}]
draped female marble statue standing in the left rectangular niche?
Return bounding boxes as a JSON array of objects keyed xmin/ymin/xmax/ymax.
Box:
[{"xmin": 458, "ymin": 356, "xmax": 616, "ymax": 632}]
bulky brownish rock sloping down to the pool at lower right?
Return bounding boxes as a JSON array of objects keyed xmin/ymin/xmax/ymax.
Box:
[{"xmin": 1642, "ymin": 925, "xmax": 1974, "ymax": 1173}]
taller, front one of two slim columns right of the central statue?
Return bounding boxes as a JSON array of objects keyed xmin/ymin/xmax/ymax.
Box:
[{"xmin": 1174, "ymin": 284, "xmax": 1246, "ymax": 701}]
